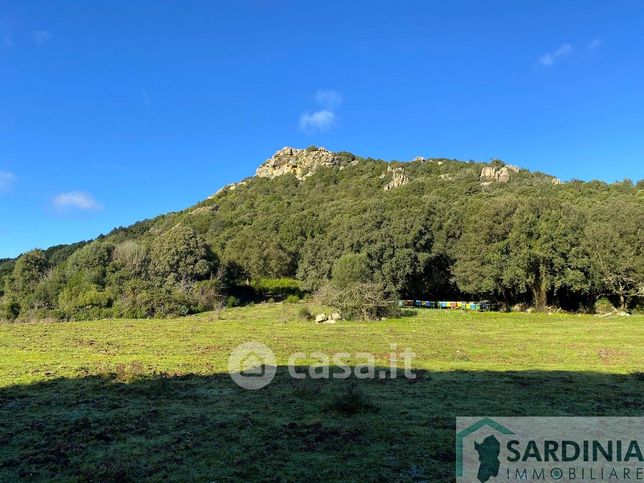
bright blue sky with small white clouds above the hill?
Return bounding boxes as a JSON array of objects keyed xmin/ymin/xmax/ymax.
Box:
[{"xmin": 0, "ymin": 0, "xmax": 644, "ymax": 257}]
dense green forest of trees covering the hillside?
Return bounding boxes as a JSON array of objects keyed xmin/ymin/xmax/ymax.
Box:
[{"xmin": 0, "ymin": 153, "xmax": 644, "ymax": 320}]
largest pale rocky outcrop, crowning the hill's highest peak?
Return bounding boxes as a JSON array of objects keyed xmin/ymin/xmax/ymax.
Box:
[{"xmin": 256, "ymin": 147, "xmax": 345, "ymax": 180}]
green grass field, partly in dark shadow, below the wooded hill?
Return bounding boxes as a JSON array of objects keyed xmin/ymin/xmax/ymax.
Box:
[{"xmin": 0, "ymin": 305, "xmax": 644, "ymax": 482}]
